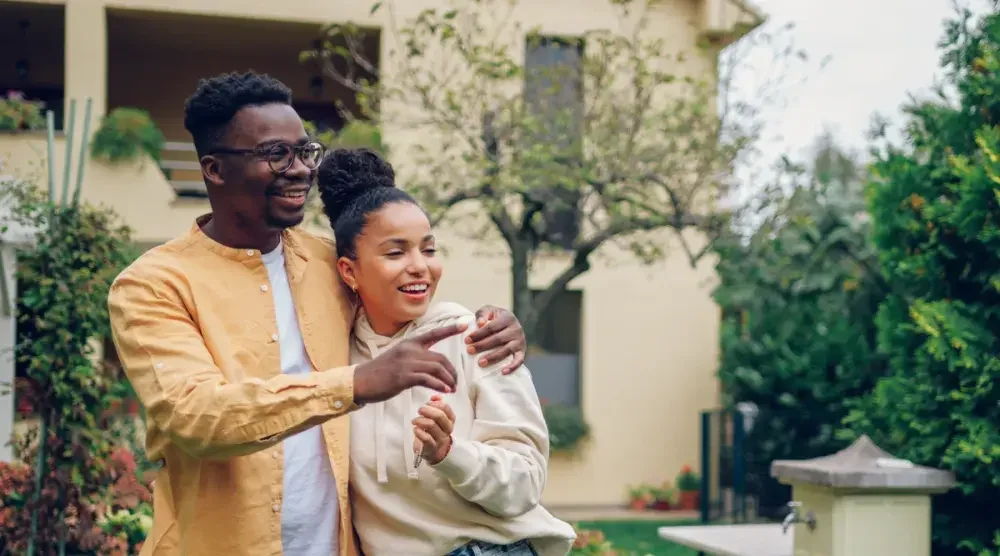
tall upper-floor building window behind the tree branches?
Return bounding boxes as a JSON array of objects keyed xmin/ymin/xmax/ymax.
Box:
[{"xmin": 524, "ymin": 35, "xmax": 584, "ymax": 249}]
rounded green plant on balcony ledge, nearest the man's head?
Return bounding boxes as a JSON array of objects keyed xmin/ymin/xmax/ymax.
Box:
[{"xmin": 90, "ymin": 107, "xmax": 166, "ymax": 164}]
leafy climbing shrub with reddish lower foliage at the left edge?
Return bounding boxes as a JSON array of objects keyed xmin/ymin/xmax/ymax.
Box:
[{"xmin": 0, "ymin": 176, "xmax": 141, "ymax": 554}]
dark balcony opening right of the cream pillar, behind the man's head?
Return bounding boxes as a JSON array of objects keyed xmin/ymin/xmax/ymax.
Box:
[{"xmin": 107, "ymin": 9, "xmax": 378, "ymax": 202}]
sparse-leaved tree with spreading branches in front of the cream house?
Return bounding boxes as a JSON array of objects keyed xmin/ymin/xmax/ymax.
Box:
[{"xmin": 304, "ymin": 0, "xmax": 788, "ymax": 340}]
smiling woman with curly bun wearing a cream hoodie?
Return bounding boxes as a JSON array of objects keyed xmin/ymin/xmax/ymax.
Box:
[{"xmin": 319, "ymin": 149, "xmax": 575, "ymax": 556}]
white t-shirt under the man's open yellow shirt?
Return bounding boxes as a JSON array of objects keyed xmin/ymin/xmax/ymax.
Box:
[{"xmin": 261, "ymin": 243, "xmax": 339, "ymax": 556}]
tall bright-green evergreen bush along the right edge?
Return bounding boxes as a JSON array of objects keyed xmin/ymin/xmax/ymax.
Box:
[{"xmin": 845, "ymin": 7, "xmax": 1000, "ymax": 556}]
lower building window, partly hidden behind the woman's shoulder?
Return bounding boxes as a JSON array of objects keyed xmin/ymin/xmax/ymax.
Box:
[{"xmin": 525, "ymin": 290, "xmax": 583, "ymax": 407}]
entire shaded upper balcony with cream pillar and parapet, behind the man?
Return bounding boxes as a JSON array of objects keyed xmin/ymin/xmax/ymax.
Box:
[{"xmin": 0, "ymin": 0, "xmax": 380, "ymax": 243}]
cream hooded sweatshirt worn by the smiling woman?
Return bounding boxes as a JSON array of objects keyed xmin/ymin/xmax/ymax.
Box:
[{"xmin": 350, "ymin": 303, "xmax": 576, "ymax": 556}]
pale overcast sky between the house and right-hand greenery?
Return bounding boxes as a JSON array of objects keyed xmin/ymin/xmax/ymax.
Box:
[{"xmin": 741, "ymin": 0, "xmax": 954, "ymax": 173}]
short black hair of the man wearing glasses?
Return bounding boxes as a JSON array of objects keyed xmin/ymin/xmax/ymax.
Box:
[{"xmin": 184, "ymin": 71, "xmax": 292, "ymax": 156}]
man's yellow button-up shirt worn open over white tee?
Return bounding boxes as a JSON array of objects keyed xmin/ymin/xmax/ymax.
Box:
[{"xmin": 108, "ymin": 215, "xmax": 357, "ymax": 556}]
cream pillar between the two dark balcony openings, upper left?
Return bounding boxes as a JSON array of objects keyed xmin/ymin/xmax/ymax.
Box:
[{"xmin": 63, "ymin": 0, "xmax": 108, "ymax": 124}]
